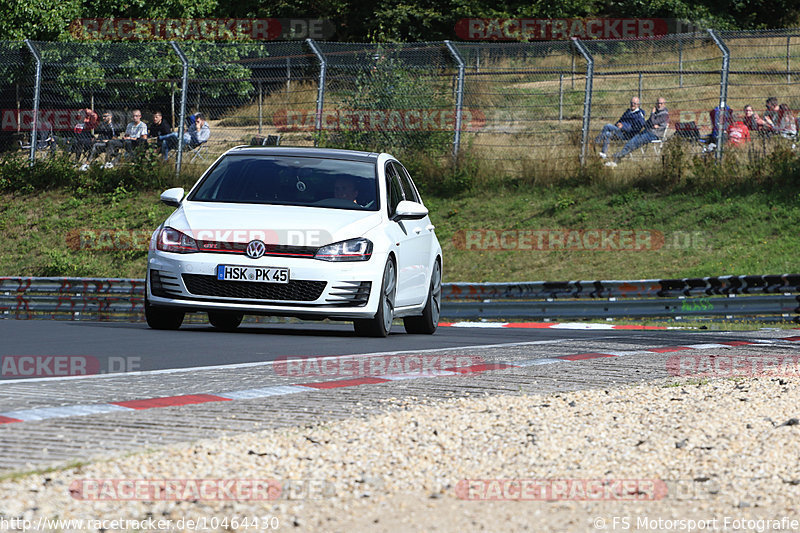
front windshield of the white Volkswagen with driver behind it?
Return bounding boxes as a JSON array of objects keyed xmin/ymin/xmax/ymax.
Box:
[{"xmin": 188, "ymin": 154, "xmax": 379, "ymax": 211}]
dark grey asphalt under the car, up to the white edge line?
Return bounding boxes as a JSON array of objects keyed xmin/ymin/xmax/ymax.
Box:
[{"xmin": 0, "ymin": 320, "xmax": 744, "ymax": 380}]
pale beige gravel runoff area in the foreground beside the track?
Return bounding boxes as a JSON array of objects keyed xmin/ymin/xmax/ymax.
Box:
[{"xmin": 0, "ymin": 377, "xmax": 800, "ymax": 533}]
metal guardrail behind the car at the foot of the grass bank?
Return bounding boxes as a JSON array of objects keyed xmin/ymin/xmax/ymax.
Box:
[{"xmin": 0, "ymin": 274, "xmax": 800, "ymax": 321}]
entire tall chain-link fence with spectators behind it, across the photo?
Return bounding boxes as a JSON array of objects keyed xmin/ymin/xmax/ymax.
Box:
[{"xmin": 0, "ymin": 29, "xmax": 800, "ymax": 175}]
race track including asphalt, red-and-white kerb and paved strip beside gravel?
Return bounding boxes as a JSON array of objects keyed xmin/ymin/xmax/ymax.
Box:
[{"xmin": 0, "ymin": 320, "xmax": 800, "ymax": 473}]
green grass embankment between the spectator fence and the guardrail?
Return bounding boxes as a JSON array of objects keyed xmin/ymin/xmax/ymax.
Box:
[{"xmin": 0, "ymin": 179, "xmax": 800, "ymax": 282}]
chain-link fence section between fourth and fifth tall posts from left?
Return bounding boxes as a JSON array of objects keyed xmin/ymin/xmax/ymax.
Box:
[{"xmin": 456, "ymin": 41, "xmax": 587, "ymax": 177}]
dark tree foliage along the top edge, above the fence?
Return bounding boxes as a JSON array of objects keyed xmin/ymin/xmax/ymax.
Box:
[{"xmin": 0, "ymin": 0, "xmax": 800, "ymax": 42}]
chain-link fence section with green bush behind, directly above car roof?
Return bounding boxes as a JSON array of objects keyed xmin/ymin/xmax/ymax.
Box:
[{"xmin": 316, "ymin": 42, "xmax": 457, "ymax": 154}]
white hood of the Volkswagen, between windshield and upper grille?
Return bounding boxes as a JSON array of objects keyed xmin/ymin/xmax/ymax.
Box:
[{"xmin": 164, "ymin": 202, "xmax": 381, "ymax": 246}]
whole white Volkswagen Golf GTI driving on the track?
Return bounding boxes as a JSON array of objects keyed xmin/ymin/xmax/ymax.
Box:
[{"xmin": 145, "ymin": 147, "xmax": 442, "ymax": 337}]
